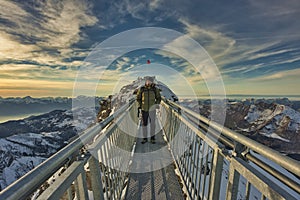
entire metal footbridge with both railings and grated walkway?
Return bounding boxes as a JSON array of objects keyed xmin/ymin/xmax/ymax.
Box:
[{"xmin": 0, "ymin": 99, "xmax": 300, "ymax": 200}]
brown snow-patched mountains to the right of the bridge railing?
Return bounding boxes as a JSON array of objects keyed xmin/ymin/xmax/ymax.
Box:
[{"xmin": 180, "ymin": 98, "xmax": 300, "ymax": 159}]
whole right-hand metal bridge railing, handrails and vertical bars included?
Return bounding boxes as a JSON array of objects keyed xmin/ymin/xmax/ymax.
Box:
[{"xmin": 161, "ymin": 100, "xmax": 300, "ymax": 199}]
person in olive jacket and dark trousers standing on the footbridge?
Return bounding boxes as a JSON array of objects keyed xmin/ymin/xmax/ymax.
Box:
[{"xmin": 136, "ymin": 77, "xmax": 161, "ymax": 144}]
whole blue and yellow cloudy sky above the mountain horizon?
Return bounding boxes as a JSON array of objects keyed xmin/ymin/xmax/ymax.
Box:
[{"xmin": 0, "ymin": 0, "xmax": 300, "ymax": 97}]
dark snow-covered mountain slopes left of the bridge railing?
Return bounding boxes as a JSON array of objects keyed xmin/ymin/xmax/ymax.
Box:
[{"xmin": 0, "ymin": 108, "xmax": 95, "ymax": 190}]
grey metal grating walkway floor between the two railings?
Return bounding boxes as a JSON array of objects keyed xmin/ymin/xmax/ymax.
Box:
[{"xmin": 125, "ymin": 131, "xmax": 184, "ymax": 200}]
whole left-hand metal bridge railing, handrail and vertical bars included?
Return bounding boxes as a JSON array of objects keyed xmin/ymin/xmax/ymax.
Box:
[{"xmin": 0, "ymin": 100, "xmax": 137, "ymax": 200}]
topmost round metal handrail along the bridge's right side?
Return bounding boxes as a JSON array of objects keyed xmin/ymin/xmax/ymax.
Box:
[{"xmin": 163, "ymin": 98, "xmax": 300, "ymax": 177}]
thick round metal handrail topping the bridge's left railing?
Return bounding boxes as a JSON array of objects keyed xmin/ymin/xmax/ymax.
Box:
[{"xmin": 0, "ymin": 99, "xmax": 134, "ymax": 200}]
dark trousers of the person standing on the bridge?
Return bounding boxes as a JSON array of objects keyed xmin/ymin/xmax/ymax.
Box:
[{"xmin": 142, "ymin": 110, "xmax": 156, "ymax": 139}]
